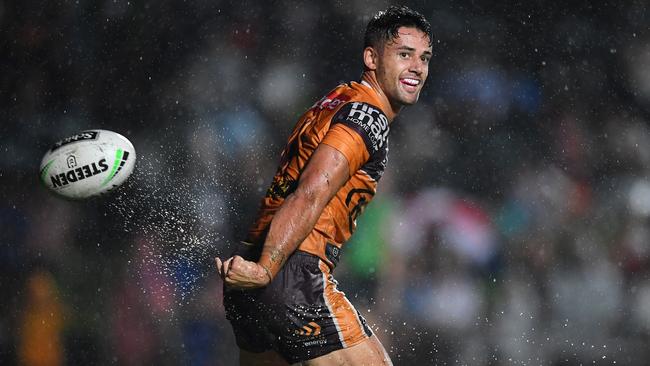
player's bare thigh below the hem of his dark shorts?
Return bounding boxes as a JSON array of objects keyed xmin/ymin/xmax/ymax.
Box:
[{"xmin": 302, "ymin": 335, "xmax": 393, "ymax": 366}]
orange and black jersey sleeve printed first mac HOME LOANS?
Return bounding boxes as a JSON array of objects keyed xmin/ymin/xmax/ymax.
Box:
[{"xmin": 322, "ymin": 102, "xmax": 389, "ymax": 176}]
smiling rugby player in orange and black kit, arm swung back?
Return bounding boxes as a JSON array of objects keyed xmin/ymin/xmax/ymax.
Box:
[{"xmin": 215, "ymin": 6, "xmax": 433, "ymax": 365}]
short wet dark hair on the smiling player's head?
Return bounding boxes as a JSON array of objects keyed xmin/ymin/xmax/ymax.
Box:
[{"xmin": 363, "ymin": 5, "xmax": 433, "ymax": 48}]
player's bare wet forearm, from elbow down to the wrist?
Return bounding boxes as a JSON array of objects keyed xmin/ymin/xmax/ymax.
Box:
[{"xmin": 258, "ymin": 191, "xmax": 326, "ymax": 277}]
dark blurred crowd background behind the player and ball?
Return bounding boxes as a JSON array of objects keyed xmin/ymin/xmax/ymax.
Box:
[{"xmin": 0, "ymin": 0, "xmax": 650, "ymax": 366}]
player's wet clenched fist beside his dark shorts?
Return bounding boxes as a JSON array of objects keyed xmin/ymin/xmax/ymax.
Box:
[{"xmin": 214, "ymin": 255, "xmax": 271, "ymax": 290}]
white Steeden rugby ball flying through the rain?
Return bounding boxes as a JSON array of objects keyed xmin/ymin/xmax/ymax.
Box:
[{"xmin": 40, "ymin": 130, "xmax": 135, "ymax": 199}]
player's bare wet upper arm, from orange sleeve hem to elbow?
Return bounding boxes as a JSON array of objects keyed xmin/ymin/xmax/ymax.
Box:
[{"xmin": 294, "ymin": 144, "xmax": 350, "ymax": 206}]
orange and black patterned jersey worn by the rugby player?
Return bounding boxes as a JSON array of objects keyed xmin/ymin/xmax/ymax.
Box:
[{"xmin": 247, "ymin": 82, "xmax": 389, "ymax": 267}]
